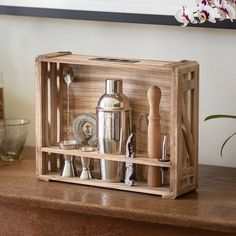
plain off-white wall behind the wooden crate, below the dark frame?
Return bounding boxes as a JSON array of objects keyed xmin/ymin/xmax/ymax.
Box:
[{"xmin": 0, "ymin": 15, "xmax": 236, "ymax": 167}]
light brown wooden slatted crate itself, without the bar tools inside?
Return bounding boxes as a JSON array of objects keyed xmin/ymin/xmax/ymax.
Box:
[{"xmin": 36, "ymin": 52, "xmax": 199, "ymax": 199}]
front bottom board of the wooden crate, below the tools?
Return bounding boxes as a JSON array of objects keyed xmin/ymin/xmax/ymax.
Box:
[{"xmin": 39, "ymin": 174, "xmax": 170, "ymax": 198}]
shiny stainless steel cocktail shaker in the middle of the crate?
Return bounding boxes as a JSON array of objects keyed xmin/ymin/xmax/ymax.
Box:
[{"xmin": 97, "ymin": 79, "xmax": 132, "ymax": 182}]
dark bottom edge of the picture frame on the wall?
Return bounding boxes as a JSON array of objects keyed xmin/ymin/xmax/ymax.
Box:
[{"xmin": 0, "ymin": 5, "xmax": 236, "ymax": 29}]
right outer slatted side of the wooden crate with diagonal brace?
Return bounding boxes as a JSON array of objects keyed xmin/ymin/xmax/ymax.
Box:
[{"xmin": 177, "ymin": 64, "xmax": 199, "ymax": 196}]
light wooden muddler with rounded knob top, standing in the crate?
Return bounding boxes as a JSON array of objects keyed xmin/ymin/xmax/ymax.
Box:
[{"xmin": 147, "ymin": 86, "xmax": 161, "ymax": 187}]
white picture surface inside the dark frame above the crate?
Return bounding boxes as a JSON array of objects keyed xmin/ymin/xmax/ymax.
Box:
[{"xmin": 0, "ymin": 0, "xmax": 196, "ymax": 15}]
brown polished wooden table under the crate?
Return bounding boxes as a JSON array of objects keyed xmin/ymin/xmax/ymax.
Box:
[{"xmin": 0, "ymin": 149, "xmax": 236, "ymax": 236}]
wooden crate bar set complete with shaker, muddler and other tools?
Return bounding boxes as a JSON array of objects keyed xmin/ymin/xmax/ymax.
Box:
[{"xmin": 36, "ymin": 52, "xmax": 199, "ymax": 199}]
